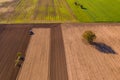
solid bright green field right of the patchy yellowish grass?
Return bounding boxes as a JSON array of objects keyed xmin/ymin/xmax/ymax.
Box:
[{"xmin": 67, "ymin": 0, "xmax": 120, "ymax": 22}]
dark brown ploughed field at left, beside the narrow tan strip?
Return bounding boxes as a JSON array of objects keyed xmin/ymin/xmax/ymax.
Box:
[{"xmin": 0, "ymin": 25, "xmax": 30, "ymax": 80}]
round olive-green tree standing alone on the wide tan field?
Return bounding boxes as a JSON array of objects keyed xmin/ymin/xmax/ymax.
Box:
[{"xmin": 82, "ymin": 31, "xmax": 96, "ymax": 43}]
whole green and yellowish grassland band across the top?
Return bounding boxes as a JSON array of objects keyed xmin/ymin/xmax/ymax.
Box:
[{"xmin": 0, "ymin": 0, "xmax": 120, "ymax": 23}]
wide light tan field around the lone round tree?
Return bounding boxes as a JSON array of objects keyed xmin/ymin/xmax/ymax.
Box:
[{"xmin": 62, "ymin": 24, "xmax": 120, "ymax": 80}]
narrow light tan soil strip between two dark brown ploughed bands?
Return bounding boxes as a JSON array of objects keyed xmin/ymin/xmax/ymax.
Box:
[{"xmin": 18, "ymin": 28, "xmax": 50, "ymax": 80}]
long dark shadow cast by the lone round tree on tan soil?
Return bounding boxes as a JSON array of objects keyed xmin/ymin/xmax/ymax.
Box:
[{"xmin": 91, "ymin": 42, "xmax": 116, "ymax": 54}]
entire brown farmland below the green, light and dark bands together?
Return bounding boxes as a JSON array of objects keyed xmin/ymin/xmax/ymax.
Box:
[{"xmin": 0, "ymin": 23, "xmax": 120, "ymax": 80}]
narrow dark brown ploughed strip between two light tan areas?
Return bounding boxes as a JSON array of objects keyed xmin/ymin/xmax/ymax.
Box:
[{"xmin": 50, "ymin": 26, "xmax": 68, "ymax": 80}]
